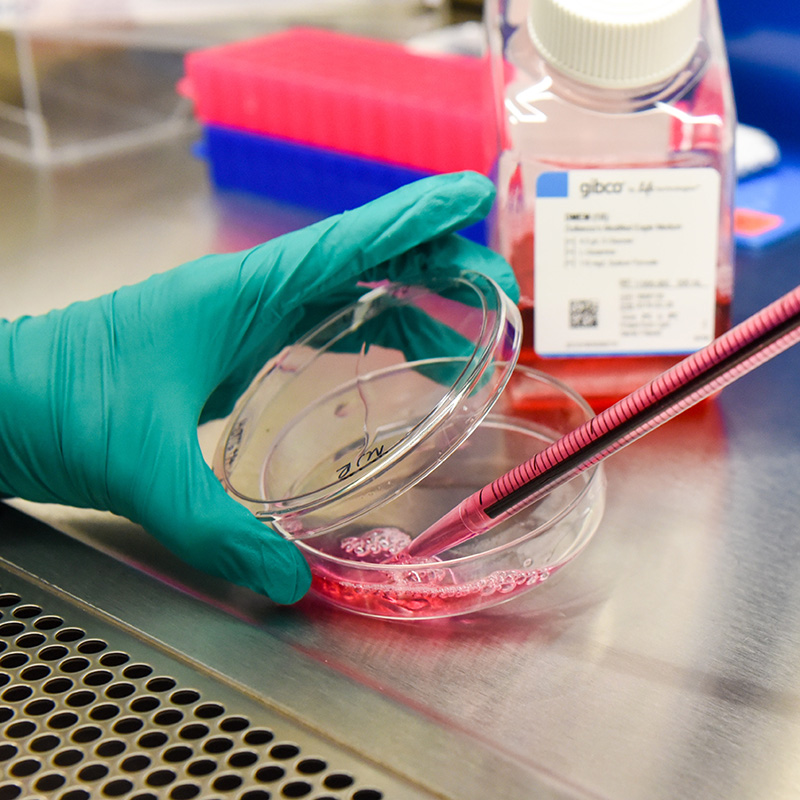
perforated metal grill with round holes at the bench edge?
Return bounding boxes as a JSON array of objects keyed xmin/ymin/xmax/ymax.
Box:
[{"xmin": 0, "ymin": 586, "xmax": 384, "ymax": 800}]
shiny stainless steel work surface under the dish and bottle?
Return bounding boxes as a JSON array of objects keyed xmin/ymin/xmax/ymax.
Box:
[{"xmin": 0, "ymin": 131, "xmax": 800, "ymax": 800}]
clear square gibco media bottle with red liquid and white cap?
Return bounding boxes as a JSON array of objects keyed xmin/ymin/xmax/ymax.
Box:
[{"xmin": 485, "ymin": 0, "xmax": 735, "ymax": 410}]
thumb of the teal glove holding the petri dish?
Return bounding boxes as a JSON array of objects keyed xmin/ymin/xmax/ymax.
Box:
[{"xmin": 133, "ymin": 434, "xmax": 311, "ymax": 603}]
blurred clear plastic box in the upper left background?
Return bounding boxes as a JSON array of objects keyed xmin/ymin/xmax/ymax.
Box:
[{"xmin": 0, "ymin": 24, "xmax": 194, "ymax": 166}]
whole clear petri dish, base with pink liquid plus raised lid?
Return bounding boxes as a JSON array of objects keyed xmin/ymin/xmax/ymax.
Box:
[{"xmin": 214, "ymin": 270, "xmax": 604, "ymax": 619}]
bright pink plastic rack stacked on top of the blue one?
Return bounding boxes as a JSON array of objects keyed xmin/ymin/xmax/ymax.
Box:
[{"xmin": 181, "ymin": 28, "xmax": 495, "ymax": 174}]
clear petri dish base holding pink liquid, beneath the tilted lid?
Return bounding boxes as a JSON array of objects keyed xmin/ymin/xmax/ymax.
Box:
[{"xmin": 298, "ymin": 366, "xmax": 605, "ymax": 619}]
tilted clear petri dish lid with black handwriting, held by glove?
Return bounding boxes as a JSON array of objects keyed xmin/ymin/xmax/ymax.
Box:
[{"xmin": 213, "ymin": 267, "xmax": 521, "ymax": 538}]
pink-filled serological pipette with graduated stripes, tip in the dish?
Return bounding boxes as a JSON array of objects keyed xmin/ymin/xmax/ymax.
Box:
[{"xmin": 400, "ymin": 286, "xmax": 800, "ymax": 561}]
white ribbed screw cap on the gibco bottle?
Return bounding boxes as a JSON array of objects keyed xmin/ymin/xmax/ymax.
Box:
[{"xmin": 528, "ymin": 0, "xmax": 701, "ymax": 89}]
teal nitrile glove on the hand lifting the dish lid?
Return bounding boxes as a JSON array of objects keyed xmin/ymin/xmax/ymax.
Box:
[{"xmin": 0, "ymin": 173, "xmax": 516, "ymax": 603}]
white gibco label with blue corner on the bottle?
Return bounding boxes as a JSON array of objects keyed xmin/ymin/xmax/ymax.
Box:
[{"xmin": 534, "ymin": 167, "xmax": 720, "ymax": 357}]
